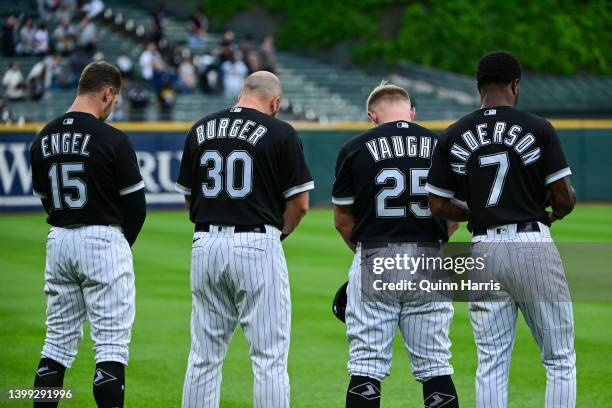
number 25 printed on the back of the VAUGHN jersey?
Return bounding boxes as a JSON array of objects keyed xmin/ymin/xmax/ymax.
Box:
[{"xmin": 376, "ymin": 168, "xmax": 431, "ymax": 218}]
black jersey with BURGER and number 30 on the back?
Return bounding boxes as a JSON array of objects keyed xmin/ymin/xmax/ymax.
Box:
[{"xmin": 176, "ymin": 107, "xmax": 314, "ymax": 228}]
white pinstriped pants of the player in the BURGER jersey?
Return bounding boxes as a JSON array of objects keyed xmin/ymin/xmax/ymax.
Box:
[{"xmin": 183, "ymin": 226, "xmax": 291, "ymax": 408}]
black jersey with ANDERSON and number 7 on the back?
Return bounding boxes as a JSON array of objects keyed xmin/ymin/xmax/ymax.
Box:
[{"xmin": 426, "ymin": 106, "xmax": 571, "ymax": 228}]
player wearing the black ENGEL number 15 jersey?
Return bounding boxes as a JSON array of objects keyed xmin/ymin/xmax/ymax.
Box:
[{"xmin": 30, "ymin": 62, "xmax": 146, "ymax": 408}]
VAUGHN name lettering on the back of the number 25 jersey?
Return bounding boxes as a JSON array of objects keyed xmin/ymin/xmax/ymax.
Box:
[{"xmin": 365, "ymin": 136, "xmax": 438, "ymax": 163}]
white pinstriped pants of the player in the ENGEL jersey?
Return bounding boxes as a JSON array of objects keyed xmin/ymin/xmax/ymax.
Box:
[{"xmin": 42, "ymin": 226, "xmax": 135, "ymax": 367}]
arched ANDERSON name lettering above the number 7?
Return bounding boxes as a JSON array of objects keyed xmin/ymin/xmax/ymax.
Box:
[{"xmin": 450, "ymin": 122, "xmax": 541, "ymax": 174}]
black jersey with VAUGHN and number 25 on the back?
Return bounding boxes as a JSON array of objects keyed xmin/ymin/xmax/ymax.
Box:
[{"xmin": 332, "ymin": 121, "xmax": 448, "ymax": 242}]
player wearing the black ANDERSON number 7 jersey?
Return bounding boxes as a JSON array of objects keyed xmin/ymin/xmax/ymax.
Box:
[{"xmin": 426, "ymin": 52, "xmax": 576, "ymax": 408}]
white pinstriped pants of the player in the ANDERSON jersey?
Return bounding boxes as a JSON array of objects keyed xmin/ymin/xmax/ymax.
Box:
[{"xmin": 470, "ymin": 223, "xmax": 576, "ymax": 408}]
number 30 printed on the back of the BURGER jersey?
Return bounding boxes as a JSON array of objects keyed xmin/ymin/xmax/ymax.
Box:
[{"xmin": 200, "ymin": 150, "xmax": 253, "ymax": 198}]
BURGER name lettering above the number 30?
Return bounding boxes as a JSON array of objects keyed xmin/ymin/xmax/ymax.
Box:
[{"xmin": 196, "ymin": 118, "xmax": 268, "ymax": 146}]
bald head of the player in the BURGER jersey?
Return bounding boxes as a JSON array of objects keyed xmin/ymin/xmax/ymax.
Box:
[{"xmin": 236, "ymin": 71, "xmax": 283, "ymax": 116}]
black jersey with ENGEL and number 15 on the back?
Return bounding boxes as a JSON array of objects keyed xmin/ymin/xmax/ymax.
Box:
[{"xmin": 30, "ymin": 112, "xmax": 144, "ymax": 227}]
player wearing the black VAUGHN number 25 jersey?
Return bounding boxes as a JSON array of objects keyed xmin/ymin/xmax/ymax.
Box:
[{"xmin": 332, "ymin": 82, "xmax": 459, "ymax": 408}]
